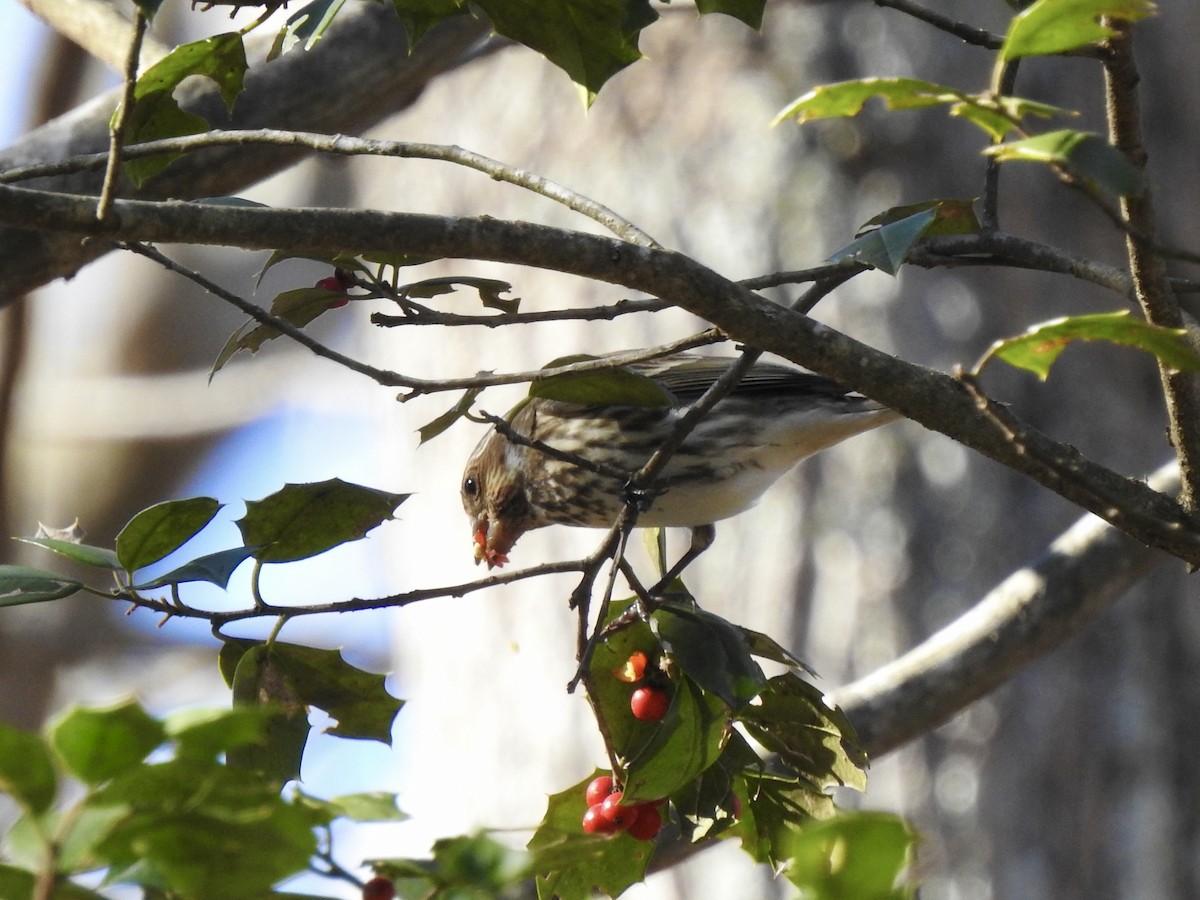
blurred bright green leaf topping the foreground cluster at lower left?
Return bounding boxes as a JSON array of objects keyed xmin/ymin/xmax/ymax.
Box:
[{"xmin": 49, "ymin": 701, "xmax": 166, "ymax": 785}]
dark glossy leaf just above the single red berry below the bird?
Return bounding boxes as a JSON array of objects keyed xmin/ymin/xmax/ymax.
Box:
[{"xmin": 650, "ymin": 604, "xmax": 767, "ymax": 709}]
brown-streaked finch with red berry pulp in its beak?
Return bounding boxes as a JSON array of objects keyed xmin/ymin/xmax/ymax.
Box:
[{"xmin": 462, "ymin": 353, "xmax": 900, "ymax": 569}]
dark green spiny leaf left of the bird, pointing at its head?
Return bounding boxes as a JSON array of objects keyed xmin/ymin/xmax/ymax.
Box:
[{"xmin": 236, "ymin": 478, "xmax": 412, "ymax": 563}]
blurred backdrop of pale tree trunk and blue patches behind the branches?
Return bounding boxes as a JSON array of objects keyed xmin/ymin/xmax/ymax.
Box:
[{"xmin": 0, "ymin": 0, "xmax": 1200, "ymax": 900}]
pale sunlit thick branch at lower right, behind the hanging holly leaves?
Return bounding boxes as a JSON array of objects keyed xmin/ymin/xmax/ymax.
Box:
[{"xmin": 833, "ymin": 463, "xmax": 1178, "ymax": 757}]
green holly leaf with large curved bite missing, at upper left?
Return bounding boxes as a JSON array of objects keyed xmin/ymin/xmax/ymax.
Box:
[{"xmin": 125, "ymin": 31, "xmax": 246, "ymax": 186}]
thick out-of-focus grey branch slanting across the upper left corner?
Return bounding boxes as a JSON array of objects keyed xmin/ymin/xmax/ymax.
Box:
[{"xmin": 0, "ymin": 4, "xmax": 488, "ymax": 297}]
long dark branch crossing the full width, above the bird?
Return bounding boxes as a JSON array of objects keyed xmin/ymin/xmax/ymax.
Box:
[{"xmin": 0, "ymin": 186, "xmax": 1200, "ymax": 564}]
